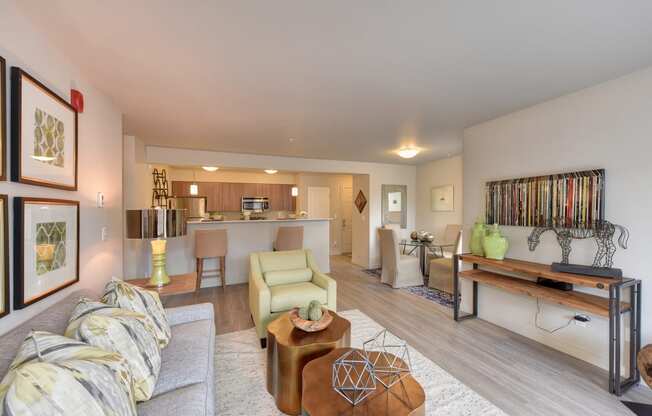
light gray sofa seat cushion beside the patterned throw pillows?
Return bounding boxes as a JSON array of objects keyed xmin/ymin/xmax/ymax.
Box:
[{"xmin": 154, "ymin": 319, "xmax": 214, "ymax": 396}]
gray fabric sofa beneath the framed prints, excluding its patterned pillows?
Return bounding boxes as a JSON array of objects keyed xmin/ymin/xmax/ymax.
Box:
[{"xmin": 0, "ymin": 290, "xmax": 215, "ymax": 416}]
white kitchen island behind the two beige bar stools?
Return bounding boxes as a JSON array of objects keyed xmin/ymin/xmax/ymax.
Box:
[{"xmin": 158, "ymin": 218, "xmax": 330, "ymax": 287}]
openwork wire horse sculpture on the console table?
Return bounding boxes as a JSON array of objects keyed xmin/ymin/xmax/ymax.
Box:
[{"xmin": 527, "ymin": 221, "xmax": 629, "ymax": 267}]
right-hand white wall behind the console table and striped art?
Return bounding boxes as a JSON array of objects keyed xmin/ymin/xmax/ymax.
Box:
[{"xmin": 464, "ymin": 69, "xmax": 652, "ymax": 368}]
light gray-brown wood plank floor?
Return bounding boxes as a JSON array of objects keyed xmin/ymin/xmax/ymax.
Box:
[{"xmin": 166, "ymin": 256, "xmax": 652, "ymax": 416}]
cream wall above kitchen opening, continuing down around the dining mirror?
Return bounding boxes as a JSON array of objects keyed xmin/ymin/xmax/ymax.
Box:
[{"xmin": 147, "ymin": 146, "xmax": 416, "ymax": 267}]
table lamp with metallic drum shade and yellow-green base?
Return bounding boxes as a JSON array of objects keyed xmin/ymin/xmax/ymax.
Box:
[{"xmin": 127, "ymin": 208, "xmax": 188, "ymax": 287}]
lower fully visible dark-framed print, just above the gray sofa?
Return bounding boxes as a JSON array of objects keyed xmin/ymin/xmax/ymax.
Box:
[{"xmin": 14, "ymin": 198, "xmax": 79, "ymax": 309}]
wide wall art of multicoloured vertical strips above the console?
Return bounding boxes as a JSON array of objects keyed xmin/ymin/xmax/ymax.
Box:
[{"xmin": 485, "ymin": 169, "xmax": 605, "ymax": 228}]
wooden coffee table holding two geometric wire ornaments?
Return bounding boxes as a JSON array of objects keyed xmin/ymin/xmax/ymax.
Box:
[{"xmin": 301, "ymin": 348, "xmax": 426, "ymax": 416}]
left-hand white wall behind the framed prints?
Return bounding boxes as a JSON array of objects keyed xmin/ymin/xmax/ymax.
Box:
[{"xmin": 0, "ymin": 1, "xmax": 123, "ymax": 333}]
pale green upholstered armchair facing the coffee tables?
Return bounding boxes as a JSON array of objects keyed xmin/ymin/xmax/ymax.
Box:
[{"xmin": 249, "ymin": 250, "xmax": 337, "ymax": 348}]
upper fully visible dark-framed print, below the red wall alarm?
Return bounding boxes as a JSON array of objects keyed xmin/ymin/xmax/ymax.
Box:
[{"xmin": 11, "ymin": 67, "xmax": 77, "ymax": 191}]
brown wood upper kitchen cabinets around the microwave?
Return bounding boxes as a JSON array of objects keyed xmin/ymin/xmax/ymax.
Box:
[{"xmin": 172, "ymin": 181, "xmax": 296, "ymax": 212}]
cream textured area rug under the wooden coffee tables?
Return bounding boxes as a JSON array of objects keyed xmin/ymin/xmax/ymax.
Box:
[{"xmin": 215, "ymin": 310, "xmax": 505, "ymax": 416}]
